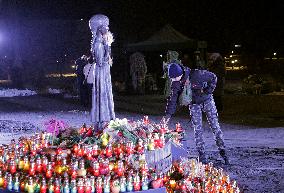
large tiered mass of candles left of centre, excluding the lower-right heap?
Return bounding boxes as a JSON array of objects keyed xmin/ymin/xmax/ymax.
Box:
[{"xmin": 0, "ymin": 133, "xmax": 168, "ymax": 193}]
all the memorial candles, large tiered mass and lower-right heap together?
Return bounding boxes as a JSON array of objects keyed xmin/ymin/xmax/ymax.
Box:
[{"xmin": 0, "ymin": 118, "xmax": 239, "ymax": 193}]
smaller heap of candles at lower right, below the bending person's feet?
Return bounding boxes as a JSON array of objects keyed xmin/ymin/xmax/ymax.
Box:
[{"xmin": 164, "ymin": 159, "xmax": 240, "ymax": 193}]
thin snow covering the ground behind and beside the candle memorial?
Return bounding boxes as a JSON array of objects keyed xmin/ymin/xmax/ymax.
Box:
[{"xmin": 0, "ymin": 96, "xmax": 284, "ymax": 193}]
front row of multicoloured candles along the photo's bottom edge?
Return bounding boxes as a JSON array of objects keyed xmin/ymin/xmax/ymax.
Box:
[{"xmin": 0, "ymin": 171, "xmax": 163, "ymax": 193}]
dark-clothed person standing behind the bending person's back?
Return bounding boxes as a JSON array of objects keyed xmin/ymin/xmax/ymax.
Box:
[{"xmin": 208, "ymin": 53, "xmax": 226, "ymax": 112}]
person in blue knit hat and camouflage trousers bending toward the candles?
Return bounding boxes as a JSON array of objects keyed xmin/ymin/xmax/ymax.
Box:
[{"xmin": 162, "ymin": 63, "xmax": 229, "ymax": 164}]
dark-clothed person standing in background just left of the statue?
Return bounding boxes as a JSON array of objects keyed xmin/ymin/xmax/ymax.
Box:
[{"xmin": 75, "ymin": 55, "xmax": 87, "ymax": 107}]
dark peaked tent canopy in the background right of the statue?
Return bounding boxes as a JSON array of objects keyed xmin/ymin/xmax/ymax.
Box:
[{"xmin": 126, "ymin": 24, "xmax": 207, "ymax": 52}]
